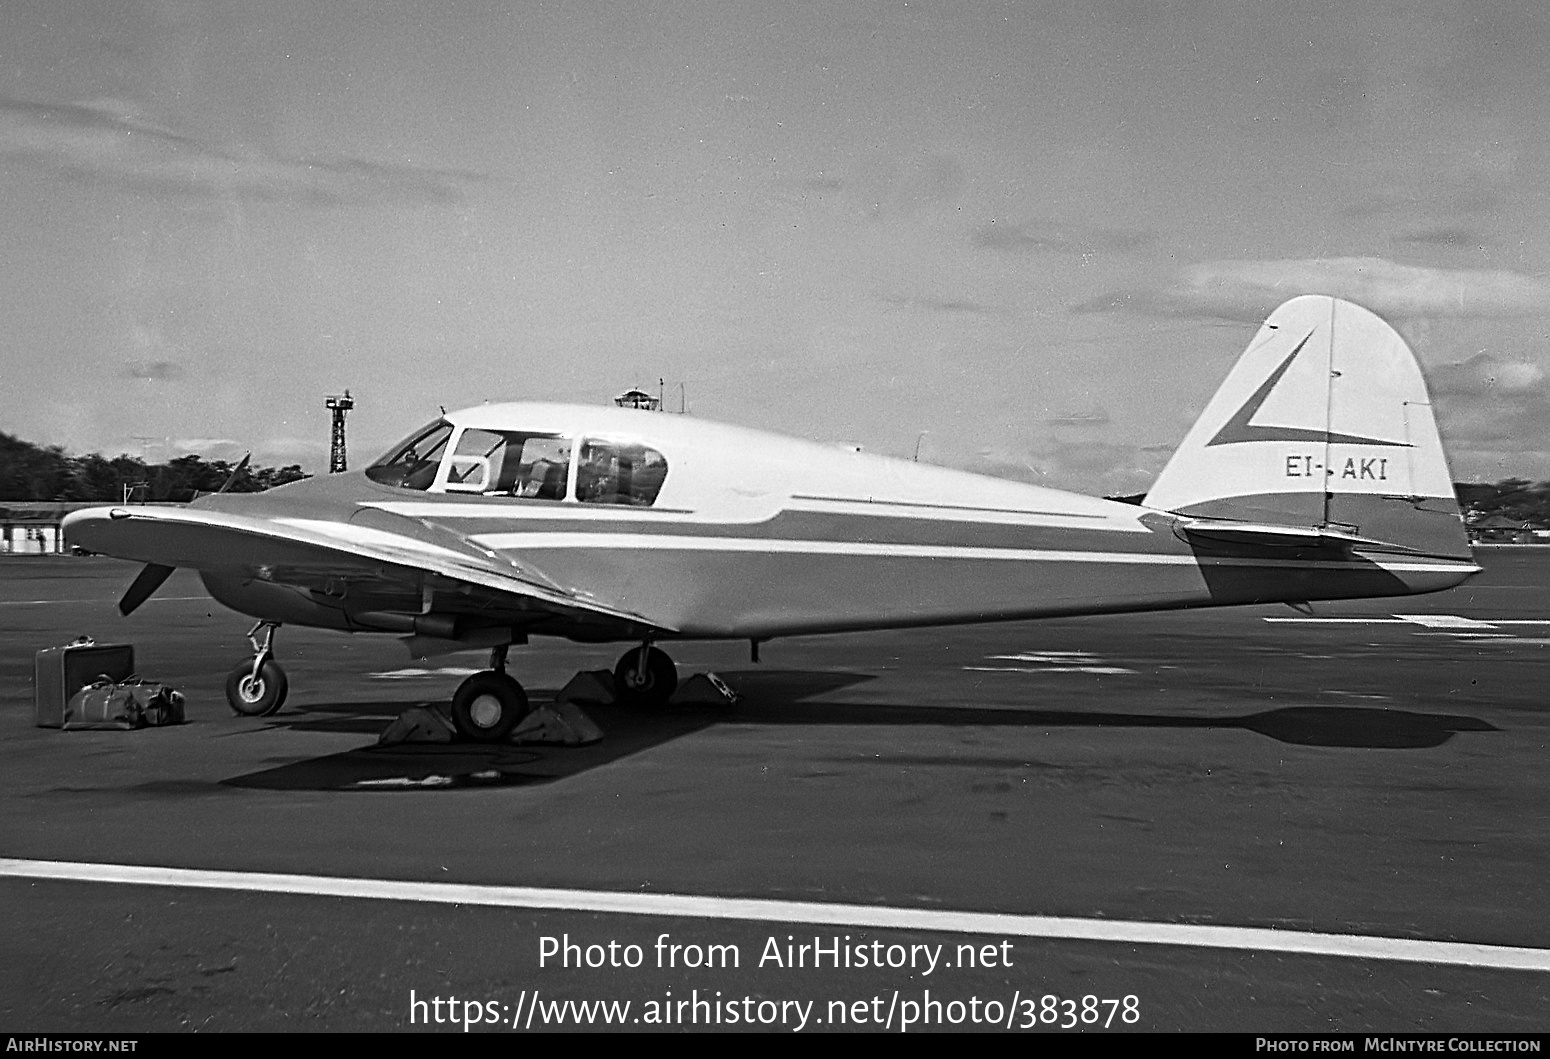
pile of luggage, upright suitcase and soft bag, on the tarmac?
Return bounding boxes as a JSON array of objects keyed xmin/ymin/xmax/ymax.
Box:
[{"xmin": 33, "ymin": 636, "xmax": 183, "ymax": 730}]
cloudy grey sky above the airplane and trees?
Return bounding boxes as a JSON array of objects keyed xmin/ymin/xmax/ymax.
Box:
[{"xmin": 0, "ymin": 0, "xmax": 1550, "ymax": 495}]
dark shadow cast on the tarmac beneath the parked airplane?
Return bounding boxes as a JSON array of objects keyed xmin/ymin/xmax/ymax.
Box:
[{"xmin": 223, "ymin": 670, "xmax": 1499, "ymax": 791}]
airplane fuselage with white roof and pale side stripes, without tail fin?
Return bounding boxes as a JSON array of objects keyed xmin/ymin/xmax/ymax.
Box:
[{"xmin": 187, "ymin": 405, "xmax": 1474, "ymax": 639}]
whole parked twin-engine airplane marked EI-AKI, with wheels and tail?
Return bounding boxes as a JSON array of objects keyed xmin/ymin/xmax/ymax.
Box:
[{"xmin": 65, "ymin": 296, "xmax": 1479, "ymax": 740}]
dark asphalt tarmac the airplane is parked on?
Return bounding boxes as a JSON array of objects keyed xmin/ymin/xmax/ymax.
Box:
[{"xmin": 0, "ymin": 549, "xmax": 1550, "ymax": 1033}]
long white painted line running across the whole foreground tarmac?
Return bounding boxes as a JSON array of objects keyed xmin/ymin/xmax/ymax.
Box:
[{"xmin": 0, "ymin": 857, "xmax": 1550, "ymax": 971}]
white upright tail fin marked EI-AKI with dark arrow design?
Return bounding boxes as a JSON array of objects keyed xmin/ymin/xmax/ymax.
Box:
[{"xmin": 1145, "ymin": 295, "xmax": 1469, "ymax": 558}]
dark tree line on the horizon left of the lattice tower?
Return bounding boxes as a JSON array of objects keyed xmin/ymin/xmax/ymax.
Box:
[{"xmin": 0, "ymin": 431, "xmax": 310, "ymax": 502}]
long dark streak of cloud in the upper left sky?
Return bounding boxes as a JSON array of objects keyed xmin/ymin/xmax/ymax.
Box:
[{"xmin": 0, "ymin": 96, "xmax": 484, "ymax": 206}]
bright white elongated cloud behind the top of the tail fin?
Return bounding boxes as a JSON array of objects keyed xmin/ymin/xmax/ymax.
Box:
[{"xmin": 1071, "ymin": 257, "xmax": 1550, "ymax": 323}]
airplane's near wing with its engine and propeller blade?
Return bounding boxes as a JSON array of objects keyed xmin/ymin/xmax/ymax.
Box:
[{"xmin": 64, "ymin": 507, "xmax": 676, "ymax": 636}]
